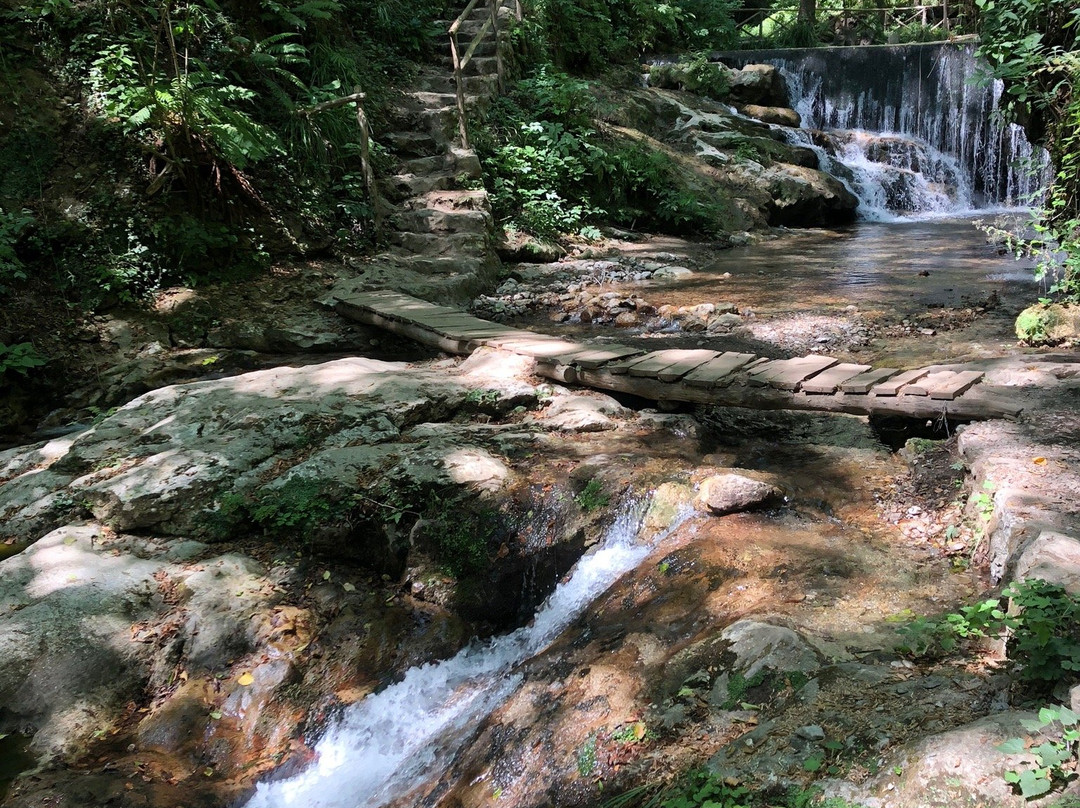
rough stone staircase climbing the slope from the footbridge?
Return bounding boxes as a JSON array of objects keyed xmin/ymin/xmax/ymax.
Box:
[{"xmin": 330, "ymin": 3, "xmax": 513, "ymax": 301}]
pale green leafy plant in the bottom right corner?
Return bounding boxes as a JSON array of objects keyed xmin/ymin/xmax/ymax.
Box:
[{"xmin": 998, "ymin": 706, "xmax": 1080, "ymax": 799}]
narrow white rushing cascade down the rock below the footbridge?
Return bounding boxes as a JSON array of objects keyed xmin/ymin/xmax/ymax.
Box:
[{"xmin": 247, "ymin": 503, "xmax": 686, "ymax": 808}]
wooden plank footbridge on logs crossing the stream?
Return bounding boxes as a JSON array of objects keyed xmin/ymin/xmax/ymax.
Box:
[{"xmin": 336, "ymin": 292, "xmax": 1021, "ymax": 420}]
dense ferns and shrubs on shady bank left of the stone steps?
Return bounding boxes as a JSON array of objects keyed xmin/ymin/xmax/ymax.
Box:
[{"xmin": 0, "ymin": 0, "xmax": 448, "ymax": 306}]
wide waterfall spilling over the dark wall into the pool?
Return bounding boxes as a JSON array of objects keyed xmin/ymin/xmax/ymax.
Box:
[{"xmin": 718, "ymin": 42, "xmax": 1048, "ymax": 220}]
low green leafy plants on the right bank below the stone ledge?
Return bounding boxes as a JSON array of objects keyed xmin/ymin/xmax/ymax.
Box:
[{"xmin": 897, "ymin": 580, "xmax": 1080, "ymax": 693}]
